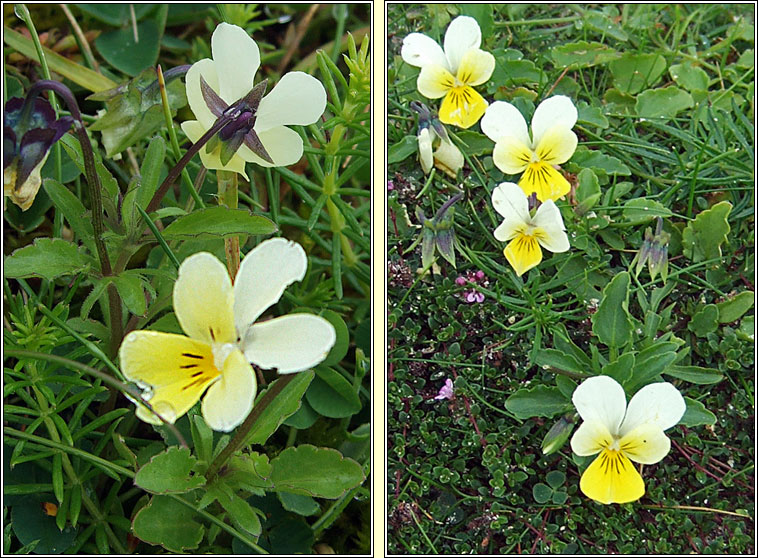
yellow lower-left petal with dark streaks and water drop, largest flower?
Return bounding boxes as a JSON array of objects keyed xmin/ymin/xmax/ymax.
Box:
[{"xmin": 119, "ymin": 331, "xmax": 220, "ymax": 424}]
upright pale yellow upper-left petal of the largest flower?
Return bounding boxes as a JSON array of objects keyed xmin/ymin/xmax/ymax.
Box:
[{"xmin": 174, "ymin": 252, "xmax": 237, "ymax": 345}]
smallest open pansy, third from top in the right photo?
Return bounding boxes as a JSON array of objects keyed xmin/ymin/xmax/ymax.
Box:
[{"xmin": 492, "ymin": 182, "xmax": 570, "ymax": 276}]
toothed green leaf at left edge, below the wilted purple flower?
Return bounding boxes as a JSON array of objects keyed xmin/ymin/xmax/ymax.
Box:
[{"xmin": 3, "ymin": 238, "xmax": 90, "ymax": 279}]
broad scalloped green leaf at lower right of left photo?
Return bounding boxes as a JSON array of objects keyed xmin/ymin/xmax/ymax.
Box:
[{"xmin": 271, "ymin": 444, "xmax": 366, "ymax": 499}]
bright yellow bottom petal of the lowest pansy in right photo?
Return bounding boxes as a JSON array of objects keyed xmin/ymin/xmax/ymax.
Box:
[{"xmin": 579, "ymin": 450, "xmax": 645, "ymax": 504}]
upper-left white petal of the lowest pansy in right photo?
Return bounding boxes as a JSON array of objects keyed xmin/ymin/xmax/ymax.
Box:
[{"xmin": 571, "ymin": 376, "xmax": 626, "ymax": 435}]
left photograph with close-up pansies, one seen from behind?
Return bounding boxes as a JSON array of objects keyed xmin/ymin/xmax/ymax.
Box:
[{"xmin": 2, "ymin": 2, "xmax": 374, "ymax": 555}]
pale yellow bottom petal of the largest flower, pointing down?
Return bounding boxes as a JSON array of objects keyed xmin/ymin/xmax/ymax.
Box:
[{"xmin": 200, "ymin": 349, "xmax": 258, "ymax": 432}]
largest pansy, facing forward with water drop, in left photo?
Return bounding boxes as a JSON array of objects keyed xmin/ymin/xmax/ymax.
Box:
[{"xmin": 119, "ymin": 238, "xmax": 336, "ymax": 432}]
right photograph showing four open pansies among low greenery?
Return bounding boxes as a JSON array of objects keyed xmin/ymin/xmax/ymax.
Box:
[{"xmin": 386, "ymin": 3, "xmax": 755, "ymax": 555}]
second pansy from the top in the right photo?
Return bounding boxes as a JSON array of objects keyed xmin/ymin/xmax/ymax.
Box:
[{"xmin": 481, "ymin": 95, "xmax": 577, "ymax": 202}]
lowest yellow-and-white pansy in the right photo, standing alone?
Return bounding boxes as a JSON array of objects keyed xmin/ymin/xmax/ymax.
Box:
[{"xmin": 571, "ymin": 376, "xmax": 687, "ymax": 504}]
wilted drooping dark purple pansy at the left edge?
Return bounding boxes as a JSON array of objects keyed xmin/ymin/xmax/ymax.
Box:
[{"xmin": 3, "ymin": 97, "xmax": 74, "ymax": 211}]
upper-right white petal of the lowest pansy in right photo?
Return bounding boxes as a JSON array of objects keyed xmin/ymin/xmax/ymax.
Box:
[{"xmin": 620, "ymin": 382, "xmax": 687, "ymax": 436}]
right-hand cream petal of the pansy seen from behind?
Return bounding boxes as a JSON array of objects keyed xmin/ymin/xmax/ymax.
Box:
[{"xmin": 255, "ymin": 72, "xmax": 326, "ymax": 132}]
